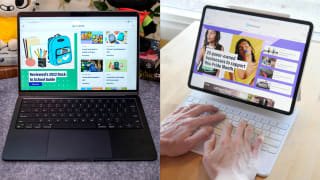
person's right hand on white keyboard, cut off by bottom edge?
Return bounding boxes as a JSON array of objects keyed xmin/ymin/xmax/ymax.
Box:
[{"xmin": 202, "ymin": 121, "xmax": 263, "ymax": 180}]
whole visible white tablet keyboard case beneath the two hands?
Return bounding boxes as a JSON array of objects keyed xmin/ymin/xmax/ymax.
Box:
[{"xmin": 181, "ymin": 92, "xmax": 296, "ymax": 176}]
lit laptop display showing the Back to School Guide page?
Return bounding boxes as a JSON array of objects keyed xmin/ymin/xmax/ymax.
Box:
[{"xmin": 19, "ymin": 16, "xmax": 138, "ymax": 91}]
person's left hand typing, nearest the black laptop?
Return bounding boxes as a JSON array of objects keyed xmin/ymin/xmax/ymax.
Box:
[{"xmin": 160, "ymin": 104, "xmax": 225, "ymax": 156}]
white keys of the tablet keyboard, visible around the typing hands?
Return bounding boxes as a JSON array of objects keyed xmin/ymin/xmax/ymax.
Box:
[{"xmin": 183, "ymin": 96, "xmax": 289, "ymax": 154}]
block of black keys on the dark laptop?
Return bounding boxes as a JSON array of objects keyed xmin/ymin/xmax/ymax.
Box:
[{"xmin": 15, "ymin": 98, "xmax": 142, "ymax": 129}]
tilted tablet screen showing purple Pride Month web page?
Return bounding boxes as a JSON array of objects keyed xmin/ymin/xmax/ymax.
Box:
[{"xmin": 189, "ymin": 8, "xmax": 312, "ymax": 112}]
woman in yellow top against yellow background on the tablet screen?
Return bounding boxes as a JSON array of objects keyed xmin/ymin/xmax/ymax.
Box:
[{"xmin": 224, "ymin": 38, "xmax": 258, "ymax": 85}]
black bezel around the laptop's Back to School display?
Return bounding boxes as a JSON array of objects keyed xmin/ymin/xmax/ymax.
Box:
[{"xmin": 17, "ymin": 11, "xmax": 140, "ymax": 95}]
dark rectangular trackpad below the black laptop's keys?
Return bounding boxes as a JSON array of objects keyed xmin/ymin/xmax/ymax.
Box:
[{"xmin": 47, "ymin": 130, "xmax": 112, "ymax": 160}]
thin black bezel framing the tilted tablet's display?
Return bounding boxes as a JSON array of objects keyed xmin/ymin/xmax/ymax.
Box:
[{"xmin": 188, "ymin": 5, "xmax": 313, "ymax": 115}]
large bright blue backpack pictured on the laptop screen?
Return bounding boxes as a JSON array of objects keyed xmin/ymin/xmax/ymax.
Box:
[{"xmin": 48, "ymin": 34, "xmax": 72, "ymax": 65}]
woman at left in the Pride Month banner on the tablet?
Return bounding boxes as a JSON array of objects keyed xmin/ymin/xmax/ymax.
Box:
[{"xmin": 197, "ymin": 30, "xmax": 224, "ymax": 76}]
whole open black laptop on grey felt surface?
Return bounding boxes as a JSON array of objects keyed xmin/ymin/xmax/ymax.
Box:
[{"xmin": 2, "ymin": 12, "xmax": 157, "ymax": 161}]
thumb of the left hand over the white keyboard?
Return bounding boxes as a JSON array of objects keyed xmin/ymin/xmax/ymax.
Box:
[{"xmin": 185, "ymin": 126, "xmax": 213, "ymax": 149}]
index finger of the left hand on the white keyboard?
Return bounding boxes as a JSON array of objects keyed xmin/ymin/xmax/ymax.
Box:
[{"xmin": 190, "ymin": 114, "xmax": 226, "ymax": 128}]
